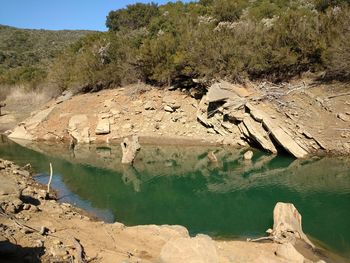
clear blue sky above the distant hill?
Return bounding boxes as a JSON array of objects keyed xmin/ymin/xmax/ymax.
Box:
[{"xmin": 0, "ymin": 0, "xmax": 191, "ymax": 30}]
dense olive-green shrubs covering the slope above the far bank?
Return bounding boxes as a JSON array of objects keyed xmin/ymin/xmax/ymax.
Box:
[{"xmin": 3, "ymin": 0, "xmax": 350, "ymax": 95}]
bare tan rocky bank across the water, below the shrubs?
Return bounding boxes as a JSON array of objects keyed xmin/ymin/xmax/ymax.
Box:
[{"xmin": 4, "ymin": 81, "xmax": 350, "ymax": 158}]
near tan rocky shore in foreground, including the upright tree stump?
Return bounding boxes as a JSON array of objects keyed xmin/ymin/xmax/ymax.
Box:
[{"xmin": 0, "ymin": 160, "xmax": 340, "ymax": 263}]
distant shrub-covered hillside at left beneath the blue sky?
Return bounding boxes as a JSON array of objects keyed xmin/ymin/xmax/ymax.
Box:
[{"xmin": 0, "ymin": 25, "xmax": 91, "ymax": 85}]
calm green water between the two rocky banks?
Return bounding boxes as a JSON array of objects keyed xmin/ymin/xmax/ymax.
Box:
[{"xmin": 0, "ymin": 138, "xmax": 350, "ymax": 258}]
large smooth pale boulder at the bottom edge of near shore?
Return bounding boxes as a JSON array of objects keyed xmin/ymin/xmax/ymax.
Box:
[{"xmin": 160, "ymin": 235, "xmax": 219, "ymax": 263}]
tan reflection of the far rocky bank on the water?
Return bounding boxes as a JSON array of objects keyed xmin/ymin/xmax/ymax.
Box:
[{"xmin": 5, "ymin": 138, "xmax": 350, "ymax": 196}]
